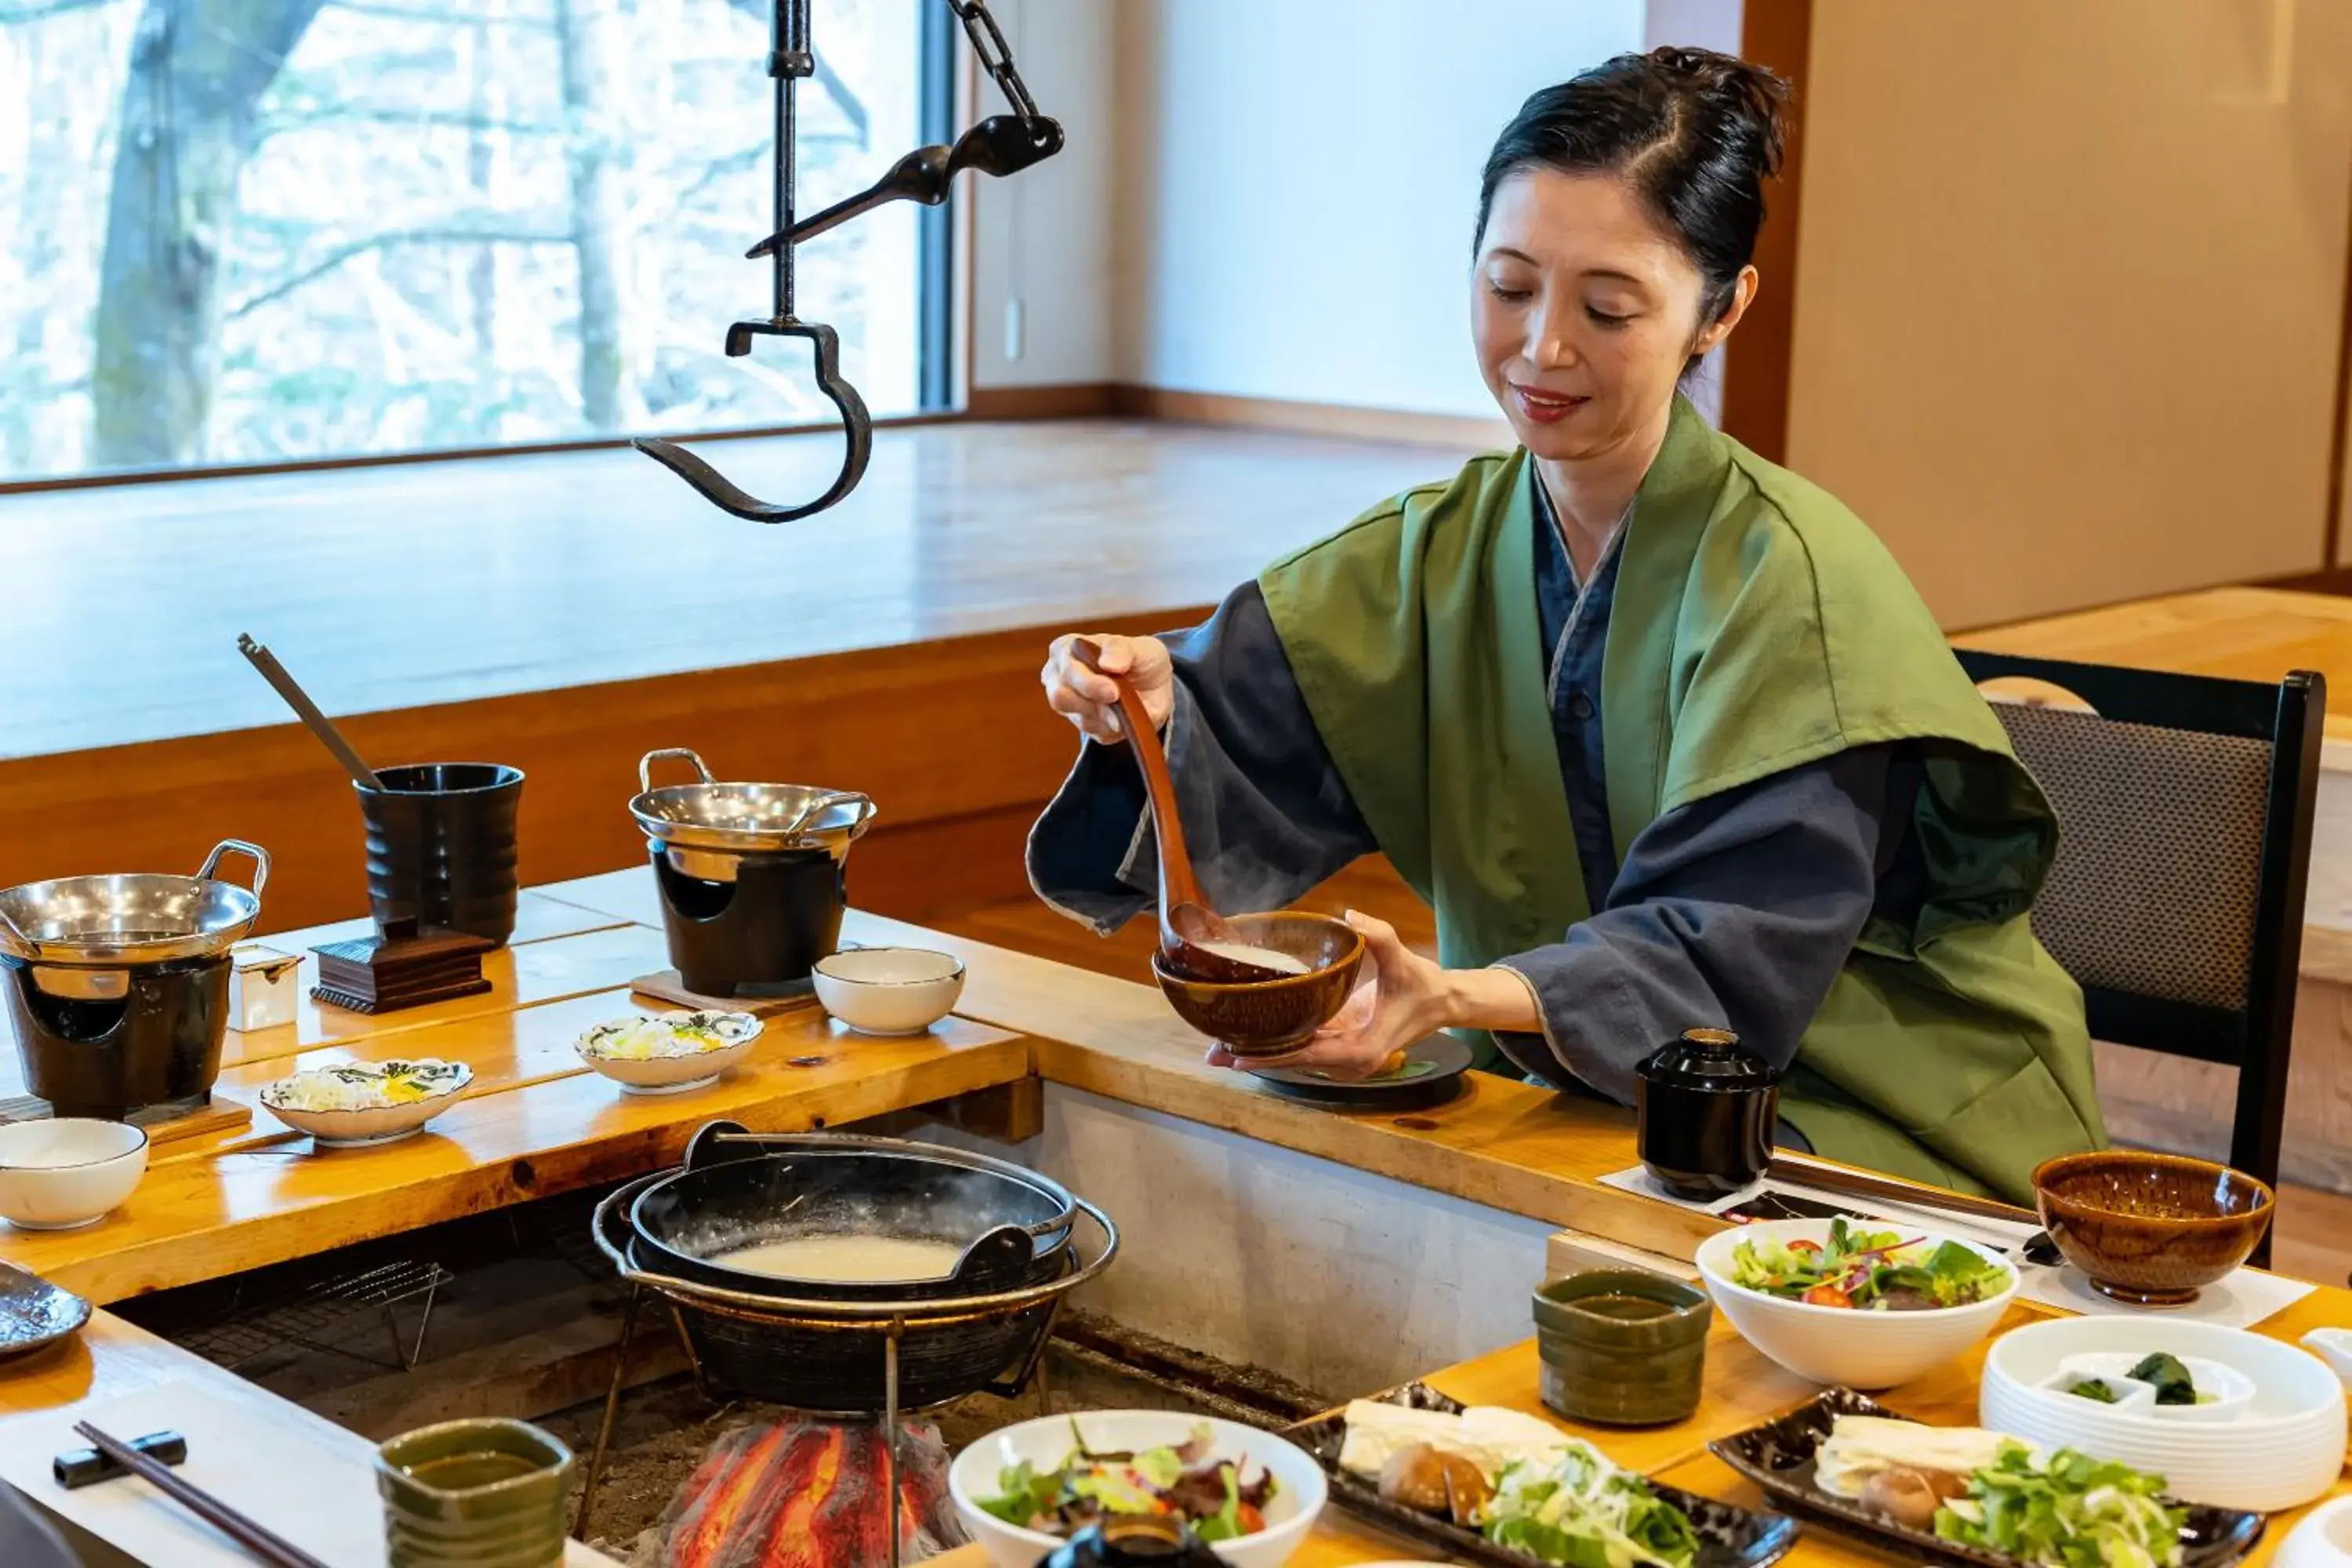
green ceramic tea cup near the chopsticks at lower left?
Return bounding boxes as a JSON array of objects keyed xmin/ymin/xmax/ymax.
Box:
[{"xmin": 376, "ymin": 1417, "xmax": 572, "ymax": 1568}]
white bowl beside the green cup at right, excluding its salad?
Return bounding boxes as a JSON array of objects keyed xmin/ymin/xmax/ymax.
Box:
[{"xmin": 1698, "ymin": 1220, "xmax": 2013, "ymax": 1403}]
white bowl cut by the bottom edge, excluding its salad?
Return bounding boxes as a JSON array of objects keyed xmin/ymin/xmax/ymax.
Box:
[{"xmin": 948, "ymin": 1410, "xmax": 1327, "ymax": 1568}]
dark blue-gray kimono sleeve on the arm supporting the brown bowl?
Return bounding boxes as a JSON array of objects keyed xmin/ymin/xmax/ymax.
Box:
[{"xmin": 1498, "ymin": 746, "xmax": 1917, "ymax": 1105}]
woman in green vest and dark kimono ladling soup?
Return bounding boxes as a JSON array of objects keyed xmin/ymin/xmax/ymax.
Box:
[{"xmin": 1030, "ymin": 49, "xmax": 2103, "ymax": 1199}]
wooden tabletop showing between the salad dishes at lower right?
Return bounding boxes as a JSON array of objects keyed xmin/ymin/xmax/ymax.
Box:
[{"xmin": 931, "ymin": 1288, "xmax": 2352, "ymax": 1568}]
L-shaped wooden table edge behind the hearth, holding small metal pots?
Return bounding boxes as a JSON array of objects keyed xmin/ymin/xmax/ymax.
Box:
[{"xmin": 0, "ymin": 869, "xmax": 1740, "ymax": 1305}]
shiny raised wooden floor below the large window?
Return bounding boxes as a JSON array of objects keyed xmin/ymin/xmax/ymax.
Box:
[{"xmin": 0, "ymin": 421, "xmax": 1461, "ymax": 762}]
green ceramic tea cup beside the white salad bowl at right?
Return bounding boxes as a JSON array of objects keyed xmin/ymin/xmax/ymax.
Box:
[{"xmin": 1536, "ymin": 1269, "xmax": 1715, "ymax": 1427}]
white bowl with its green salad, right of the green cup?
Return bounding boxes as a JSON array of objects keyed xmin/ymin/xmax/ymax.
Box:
[{"xmin": 1696, "ymin": 1220, "xmax": 2018, "ymax": 1389}]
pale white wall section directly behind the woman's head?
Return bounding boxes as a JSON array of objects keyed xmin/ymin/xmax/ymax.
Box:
[{"xmin": 1105, "ymin": 0, "xmax": 1646, "ymax": 416}]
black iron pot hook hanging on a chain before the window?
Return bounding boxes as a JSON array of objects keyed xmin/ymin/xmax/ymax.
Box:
[{"xmin": 630, "ymin": 0, "xmax": 1061, "ymax": 522}]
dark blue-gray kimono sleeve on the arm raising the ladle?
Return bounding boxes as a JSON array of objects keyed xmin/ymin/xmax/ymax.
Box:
[{"xmin": 1028, "ymin": 583, "xmax": 1374, "ymax": 935}]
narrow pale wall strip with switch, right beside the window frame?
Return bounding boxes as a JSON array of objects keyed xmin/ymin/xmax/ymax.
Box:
[{"xmin": 955, "ymin": 0, "xmax": 1127, "ymax": 388}]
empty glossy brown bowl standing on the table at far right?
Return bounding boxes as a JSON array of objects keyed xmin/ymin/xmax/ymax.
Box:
[{"xmin": 2034, "ymin": 1149, "xmax": 2277, "ymax": 1307}]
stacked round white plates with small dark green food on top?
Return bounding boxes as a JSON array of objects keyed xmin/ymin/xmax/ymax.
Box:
[{"xmin": 1978, "ymin": 1316, "xmax": 2345, "ymax": 1514}]
